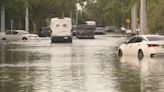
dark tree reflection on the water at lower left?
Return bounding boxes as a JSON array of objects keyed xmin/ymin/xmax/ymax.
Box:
[{"xmin": 0, "ymin": 44, "xmax": 50, "ymax": 92}]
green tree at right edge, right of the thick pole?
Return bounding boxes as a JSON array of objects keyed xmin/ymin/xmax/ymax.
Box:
[{"xmin": 148, "ymin": 0, "xmax": 164, "ymax": 34}]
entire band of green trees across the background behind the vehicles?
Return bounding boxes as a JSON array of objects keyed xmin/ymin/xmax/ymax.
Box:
[{"xmin": 0, "ymin": 0, "xmax": 164, "ymax": 32}]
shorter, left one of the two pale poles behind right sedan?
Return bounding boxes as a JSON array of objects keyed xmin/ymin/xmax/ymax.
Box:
[{"xmin": 131, "ymin": 3, "xmax": 137, "ymax": 33}]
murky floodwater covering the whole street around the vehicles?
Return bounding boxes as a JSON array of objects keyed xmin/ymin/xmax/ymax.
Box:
[{"xmin": 0, "ymin": 34, "xmax": 164, "ymax": 92}]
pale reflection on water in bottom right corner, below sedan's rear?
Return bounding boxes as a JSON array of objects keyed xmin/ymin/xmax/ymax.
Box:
[{"xmin": 141, "ymin": 57, "xmax": 164, "ymax": 92}]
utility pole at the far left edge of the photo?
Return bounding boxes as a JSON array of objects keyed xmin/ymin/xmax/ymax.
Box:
[{"xmin": 1, "ymin": 7, "xmax": 5, "ymax": 32}]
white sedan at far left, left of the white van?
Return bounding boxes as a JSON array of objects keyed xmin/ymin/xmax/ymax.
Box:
[{"xmin": 0, "ymin": 30, "xmax": 38, "ymax": 41}]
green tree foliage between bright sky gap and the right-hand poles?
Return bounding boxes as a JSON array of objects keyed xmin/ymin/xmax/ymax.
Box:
[{"xmin": 86, "ymin": 0, "xmax": 136, "ymax": 27}]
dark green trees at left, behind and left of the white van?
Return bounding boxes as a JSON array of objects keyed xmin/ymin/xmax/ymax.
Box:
[{"xmin": 0, "ymin": 0, "xmax": 77, "ymax": 33}]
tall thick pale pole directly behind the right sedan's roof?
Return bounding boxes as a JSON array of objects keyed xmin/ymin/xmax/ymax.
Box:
[{"xmin": 140, "ymin": 0, "xmax": 148, "ymax": 34}]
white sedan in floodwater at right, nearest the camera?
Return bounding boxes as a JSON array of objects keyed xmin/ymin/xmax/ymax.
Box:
[{"xmin": 118, "ymin": 35, "xmax": 164, "ymax": 59}]
